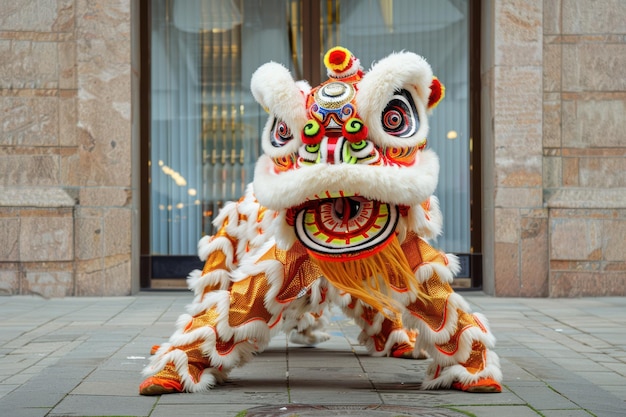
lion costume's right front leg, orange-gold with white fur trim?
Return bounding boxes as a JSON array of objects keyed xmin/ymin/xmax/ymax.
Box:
[{"xmin": 400, "ymin": 232, "xmax": 502, "ymax": 392}]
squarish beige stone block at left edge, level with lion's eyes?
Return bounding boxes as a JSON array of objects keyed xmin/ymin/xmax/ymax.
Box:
[{"xmin": 0, "ymin": 96, "xmax": 59, "ymax": 146}]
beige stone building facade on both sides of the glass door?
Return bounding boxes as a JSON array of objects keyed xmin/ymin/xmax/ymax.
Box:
[{"xmin": 0, "ymin": 0, "xmax": 626, "ymax": 297}]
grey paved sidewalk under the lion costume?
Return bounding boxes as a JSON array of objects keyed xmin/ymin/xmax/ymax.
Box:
[{"xmin": 0, "ymin": 292, "xmax": 626, "ymax": 417}]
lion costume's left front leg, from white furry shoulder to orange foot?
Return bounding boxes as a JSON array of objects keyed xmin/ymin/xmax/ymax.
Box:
[{"xmin": 140, "ymin": 188, "xmax": 319, "ymax": 395}]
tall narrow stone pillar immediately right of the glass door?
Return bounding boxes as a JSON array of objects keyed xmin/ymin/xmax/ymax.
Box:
[{"xmin": 481, "ymin": 0, "xmax": 548, "ymax": 296}]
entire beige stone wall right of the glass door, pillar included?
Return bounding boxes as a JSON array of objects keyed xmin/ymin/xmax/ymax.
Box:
[{"xmin": 482, "ymin": 0, "xmax": 626, "ymax": 297}]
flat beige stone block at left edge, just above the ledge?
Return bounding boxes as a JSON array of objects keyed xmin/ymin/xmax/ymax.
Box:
[{"xmin": 0, "ymin": 150, "xmax": 59, "ymax": 186}]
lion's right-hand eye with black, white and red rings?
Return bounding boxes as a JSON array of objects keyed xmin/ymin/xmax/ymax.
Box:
[{"xmin": 381, "ymin": 90, "xmax": 419, "ymax": 138}]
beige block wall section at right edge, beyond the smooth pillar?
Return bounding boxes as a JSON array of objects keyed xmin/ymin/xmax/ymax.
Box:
[{"xmin": 544, "ymin": 0, "xmax": 626, "ymax": 297}]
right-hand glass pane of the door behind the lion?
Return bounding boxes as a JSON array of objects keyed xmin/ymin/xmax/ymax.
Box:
[{"xmin": 320, "ymin": 0, "xmax": 471, "ymax": 253}]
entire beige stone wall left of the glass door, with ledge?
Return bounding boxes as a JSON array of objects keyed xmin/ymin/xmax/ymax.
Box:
[{"xmin": 0, "ymin": 0, "xmax": 134, "ymax": 296}]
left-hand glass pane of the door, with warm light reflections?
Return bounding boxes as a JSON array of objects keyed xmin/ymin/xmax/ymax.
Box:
[{"xmin": 150, "ymin": 0, "xmax": 302, "ymax": 255}]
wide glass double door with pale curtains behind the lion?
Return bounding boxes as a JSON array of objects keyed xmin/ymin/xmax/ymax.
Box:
[{"xmin": 142, "ymin": 0, "xmax": 472, "ymax": 288}]
